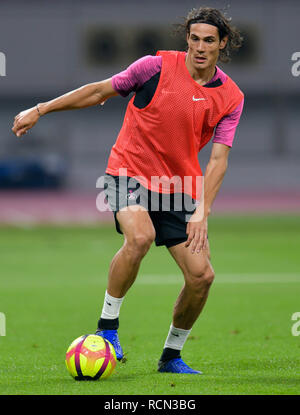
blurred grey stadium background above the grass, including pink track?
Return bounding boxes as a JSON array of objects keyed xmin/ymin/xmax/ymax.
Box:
[{"xmin": 0, "ymin": 0, "xmax": 300, "ymax": 224}]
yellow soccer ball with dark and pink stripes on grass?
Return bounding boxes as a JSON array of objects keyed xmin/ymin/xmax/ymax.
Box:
[{"xmin": 66, "ymin": 334, "xmax": 117, "ymax": 380}]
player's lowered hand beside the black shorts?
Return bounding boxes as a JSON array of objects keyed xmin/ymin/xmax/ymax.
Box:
[{"xmin": 185, "ymin": 211, "xmax": 208, "ymax": 254}]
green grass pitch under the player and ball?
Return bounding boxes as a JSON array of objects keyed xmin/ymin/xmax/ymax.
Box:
[{"xmin": 0, "ymin": 216, "xmax": 300, "ymax": 395}]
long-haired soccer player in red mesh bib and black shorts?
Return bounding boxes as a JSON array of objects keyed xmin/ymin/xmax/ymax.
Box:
[{"xmin": 12, "ymin": 8, "xmax": 244, "ymax": 374}]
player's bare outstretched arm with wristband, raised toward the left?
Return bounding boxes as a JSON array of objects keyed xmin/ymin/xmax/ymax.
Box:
[{"xmin": 12, "ymin": 78, "xmax": 118, "ymax": 137}]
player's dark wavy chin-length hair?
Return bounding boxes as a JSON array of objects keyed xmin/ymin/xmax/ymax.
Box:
[{"xmin": 175, "ymin": 7, "xmax": 243, "ymax": 62}]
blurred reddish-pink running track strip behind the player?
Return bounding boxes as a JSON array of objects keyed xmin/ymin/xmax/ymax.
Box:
[{"xmin": 0, "ymin": 191, "xmax": 300, "ymax": 224}]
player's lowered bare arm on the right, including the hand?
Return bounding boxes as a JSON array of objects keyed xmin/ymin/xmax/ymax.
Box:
[{"xmin": 185, "ymin": 143, "xmax": 230, "ymax": 253}]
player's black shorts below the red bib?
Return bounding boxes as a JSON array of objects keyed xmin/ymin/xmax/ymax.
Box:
[{"xmin": 104, "ymin": 174, "xmax": 196, "ymax": 248}]
